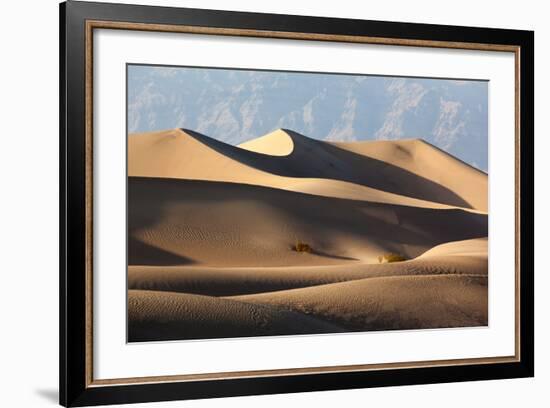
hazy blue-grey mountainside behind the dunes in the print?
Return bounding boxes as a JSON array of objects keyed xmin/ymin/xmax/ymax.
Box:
[{"xmin": 128, "ymin": 65, "xmax": 488, "ymax": 171}]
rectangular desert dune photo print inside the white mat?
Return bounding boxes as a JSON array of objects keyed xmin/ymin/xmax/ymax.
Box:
[{"xmin": 127, "ymin": 64, "xmax": 488, "ymax": 342}]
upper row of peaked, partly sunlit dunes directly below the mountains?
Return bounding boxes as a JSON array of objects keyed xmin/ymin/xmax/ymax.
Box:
[{"xmin": 132, "ymin": 129, "xmax": 487, "ymax": 211}]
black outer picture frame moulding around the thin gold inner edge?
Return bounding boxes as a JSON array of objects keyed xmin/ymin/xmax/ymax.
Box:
[{"xmin": 59, "ymin": 1, "xmax": 534, "ymax": 406}]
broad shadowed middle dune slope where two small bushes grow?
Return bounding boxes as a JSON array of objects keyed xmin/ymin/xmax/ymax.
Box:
[{"xmin": 128, "ymin": 177, "xmax": 487, "ymax": 267}]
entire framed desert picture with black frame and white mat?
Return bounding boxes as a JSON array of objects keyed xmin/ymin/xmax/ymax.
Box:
[{"xmin": 60, "ymin": 1, "xmax": 534, "ymax": 406}]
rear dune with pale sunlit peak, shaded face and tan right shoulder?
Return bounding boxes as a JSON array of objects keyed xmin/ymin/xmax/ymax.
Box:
[{"xmin": 239, "ymin": 129, "xmax": 487, "ymax": 211}]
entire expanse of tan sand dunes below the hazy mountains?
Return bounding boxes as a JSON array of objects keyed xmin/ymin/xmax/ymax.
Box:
[{"xmin": 128, "ymin": 129, "xmax": 488, "ymax": 341}]
